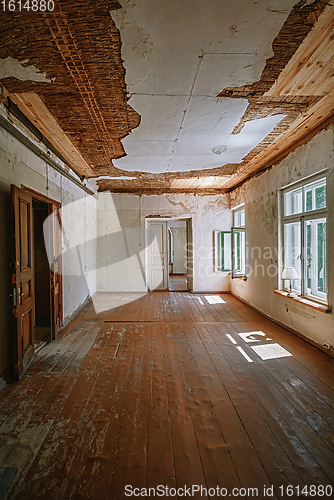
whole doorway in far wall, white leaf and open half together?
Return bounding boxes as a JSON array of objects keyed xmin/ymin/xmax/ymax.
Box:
[{"xmin": 146, "ymin": 217, "xmax": 193, "ymax": 291}]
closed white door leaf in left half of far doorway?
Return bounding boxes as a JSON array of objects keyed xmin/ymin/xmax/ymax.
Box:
[{"xmin": 147, "ymin": 221, "xmax": 168, "ymax": 290}]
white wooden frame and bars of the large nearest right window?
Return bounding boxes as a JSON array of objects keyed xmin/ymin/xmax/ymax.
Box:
[{"xmin": 279, "ymin": 171, "xmax": 328, "ymax": 304}]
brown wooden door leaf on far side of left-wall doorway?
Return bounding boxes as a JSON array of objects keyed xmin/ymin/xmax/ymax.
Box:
[{"xmin": 48, "ymin": 203, "xmax": 63, "ymax": 339}]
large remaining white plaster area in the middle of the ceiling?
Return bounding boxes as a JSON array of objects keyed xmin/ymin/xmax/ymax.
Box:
[{"xmin": 111, "ymin": 0, "xmax": 295, "ymax": 173}]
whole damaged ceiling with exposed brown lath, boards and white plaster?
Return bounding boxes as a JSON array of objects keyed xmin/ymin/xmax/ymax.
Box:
[{"xmin": 0, "ymin": 0, "xmax": 334, "ymax": 194}]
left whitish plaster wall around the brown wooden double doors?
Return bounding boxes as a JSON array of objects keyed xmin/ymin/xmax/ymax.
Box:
[{"xmin": 0, "ymin": 114, "xmax": 96, "ymax": 377}]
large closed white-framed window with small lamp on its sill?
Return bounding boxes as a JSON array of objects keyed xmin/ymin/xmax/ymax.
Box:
[{"xmin": 283, "ymin": 176, "xmax": 327, "ymax": 301}]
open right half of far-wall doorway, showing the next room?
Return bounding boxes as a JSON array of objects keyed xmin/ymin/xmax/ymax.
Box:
[{"xmin": 168, "ymin": 220, "xmax": 189, "ymax": 291}]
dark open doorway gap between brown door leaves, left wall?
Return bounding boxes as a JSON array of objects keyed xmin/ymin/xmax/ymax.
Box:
[{"xmin": 32, "ymin": 198, "xmax": 51, "ymax": 343}]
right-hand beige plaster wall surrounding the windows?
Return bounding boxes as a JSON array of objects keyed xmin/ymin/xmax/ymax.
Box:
[{"xmin": 231, "ymin": 126, "xmax": 334, "ymax": 345}]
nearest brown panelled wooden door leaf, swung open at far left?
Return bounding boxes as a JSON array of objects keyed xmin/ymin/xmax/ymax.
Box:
[{"xmin": 12, "ymin": 186, "xmax": 34, "ymax": 378}]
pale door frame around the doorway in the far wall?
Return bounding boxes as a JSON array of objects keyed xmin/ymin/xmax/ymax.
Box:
[{"xmin": 145, "ymin": 216, "xmax": 194, "ymax": 292}]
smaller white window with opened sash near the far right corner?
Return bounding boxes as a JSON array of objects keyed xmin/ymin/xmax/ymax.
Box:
[{"xmin": 215, "ymin": 208, "xmax": 246, "ymax": 278}]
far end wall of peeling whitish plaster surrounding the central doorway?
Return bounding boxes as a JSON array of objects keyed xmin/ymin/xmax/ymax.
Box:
[{"xmin": 97, "ymin": 192, "xmax": 231, "ymax": 292}]
